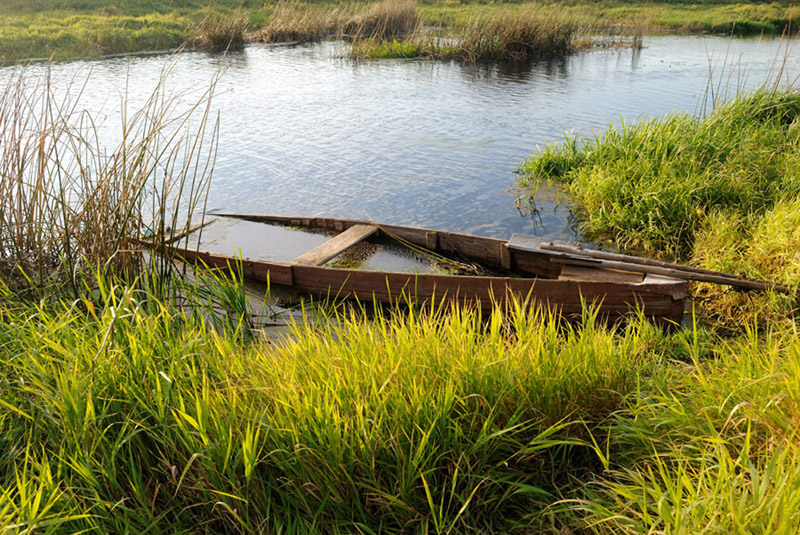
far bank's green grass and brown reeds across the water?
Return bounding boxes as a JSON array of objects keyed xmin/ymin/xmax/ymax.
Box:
[{"xmin": 0, "ymin": 0, "xmax": 798, "ymax": 61}]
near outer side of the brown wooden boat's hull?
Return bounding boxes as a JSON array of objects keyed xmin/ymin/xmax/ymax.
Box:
[{"xmin": 173, "ymin": 248, "xmax": 687, "ymax": 323}]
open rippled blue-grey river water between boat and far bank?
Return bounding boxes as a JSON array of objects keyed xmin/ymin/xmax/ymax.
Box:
[{"xmin": 0, "ymin": 36, "xmax": 800, "ymax": 239}]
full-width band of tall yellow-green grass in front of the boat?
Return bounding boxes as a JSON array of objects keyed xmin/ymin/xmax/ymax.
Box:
[{"xmin": 0, "ymin": 287, "xmax": 800, "ymax": 535}]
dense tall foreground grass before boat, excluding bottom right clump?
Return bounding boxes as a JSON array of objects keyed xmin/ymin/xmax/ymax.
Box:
[{"xmin": 0, "ymin": 292, "xmax": 660, "ymax": 533}]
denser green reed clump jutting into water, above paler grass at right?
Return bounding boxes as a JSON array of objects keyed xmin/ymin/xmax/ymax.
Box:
[{"xmin": 520, "ymin": 90, "xmax": 800, "ymax": 256}]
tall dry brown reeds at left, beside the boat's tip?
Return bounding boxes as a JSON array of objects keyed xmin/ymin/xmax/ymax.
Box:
[{"xmin": 0, "ymin": 65, "xmax": 216, "ymax": 296}]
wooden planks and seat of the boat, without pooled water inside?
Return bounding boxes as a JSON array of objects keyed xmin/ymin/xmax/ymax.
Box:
[{"xmin": 171, "ymin": 214, "xmax": 687, "ymax": 323}]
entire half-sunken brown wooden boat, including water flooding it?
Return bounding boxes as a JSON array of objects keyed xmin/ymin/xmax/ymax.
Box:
[{"xmin": 164, "ymin": 214, "xmax": 687, "ymax": 323}]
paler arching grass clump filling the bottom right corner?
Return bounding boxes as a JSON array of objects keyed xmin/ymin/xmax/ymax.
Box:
[{"xmin": 573, "ymin": 322, "xmax": 800, "ymax": 535}]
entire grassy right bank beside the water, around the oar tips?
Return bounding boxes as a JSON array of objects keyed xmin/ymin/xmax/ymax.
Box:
[{"xmin": 521, "ymin": 90, "xmax": 800, "ymax": 321}]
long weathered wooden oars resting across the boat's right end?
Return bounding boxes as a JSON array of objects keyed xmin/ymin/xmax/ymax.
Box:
[{"xmin": 539, "ymin": 242, "xmax": 796, "ymax": 295}]
